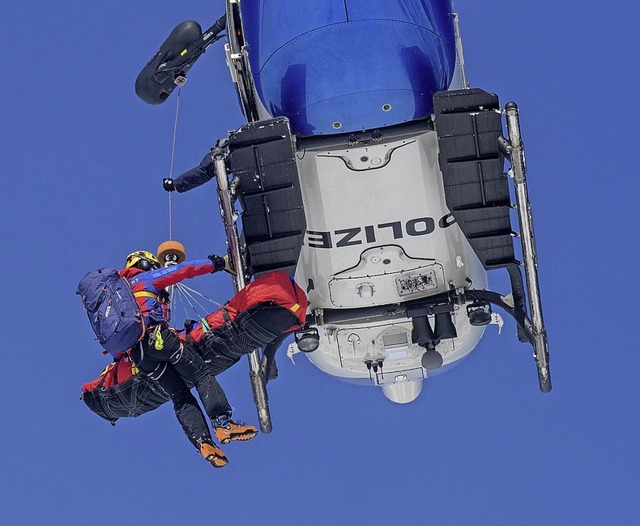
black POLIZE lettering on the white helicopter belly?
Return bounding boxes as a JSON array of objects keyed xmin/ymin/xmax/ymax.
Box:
[{"xmin": 306, "ymin": 214, "xmax": 456, "ymax": 248}]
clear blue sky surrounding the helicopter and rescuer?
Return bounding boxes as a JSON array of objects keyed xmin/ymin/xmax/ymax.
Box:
[{"xmin": 0, "ymin": 0, "xmax": 640, "ymax": 526}]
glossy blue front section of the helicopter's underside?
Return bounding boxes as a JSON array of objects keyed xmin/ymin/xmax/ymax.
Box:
[{"xmin": 240, "ymin": 0, "xmax": 456, "ymax": 136}]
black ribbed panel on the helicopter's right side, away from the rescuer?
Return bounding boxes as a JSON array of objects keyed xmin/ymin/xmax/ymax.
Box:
[{"xmin": 433, "ymin": 88, "xmax": 516, "ymax": 270}]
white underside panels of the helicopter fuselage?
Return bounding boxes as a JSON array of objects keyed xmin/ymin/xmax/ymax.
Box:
[{"xmin": 296, "ymin": 131, "xmax": 487, "ymax": 400}]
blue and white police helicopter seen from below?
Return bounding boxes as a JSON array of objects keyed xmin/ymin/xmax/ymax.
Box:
[{"xmin": 136, "ymin": 0, "xmax": 551, "ymax": 432}]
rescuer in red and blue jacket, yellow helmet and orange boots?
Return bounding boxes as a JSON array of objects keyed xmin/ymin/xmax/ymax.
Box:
[{"xmin": 120, "ymin": 250, "xmax": 258, "ymax": 468}]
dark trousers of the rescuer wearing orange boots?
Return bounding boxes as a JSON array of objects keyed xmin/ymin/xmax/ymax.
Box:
[{"xmin": 132, "ymin": 327, "xmax": 231, "ymax": 447}]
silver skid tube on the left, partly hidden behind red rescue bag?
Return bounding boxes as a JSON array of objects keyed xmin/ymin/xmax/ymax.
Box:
[{"xmin": 212, "ymin": 148, "xmax": 272, "ymax": 433}]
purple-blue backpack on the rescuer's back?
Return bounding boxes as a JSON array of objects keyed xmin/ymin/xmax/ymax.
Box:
[{"xmin": 76, "ymin": 268, "xmax": 144, "ymax": 359}]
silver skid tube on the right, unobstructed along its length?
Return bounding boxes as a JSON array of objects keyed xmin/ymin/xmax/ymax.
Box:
[{"xmin": 502, "ymin": 102, "xmax": 551, "ymax": 393}]
